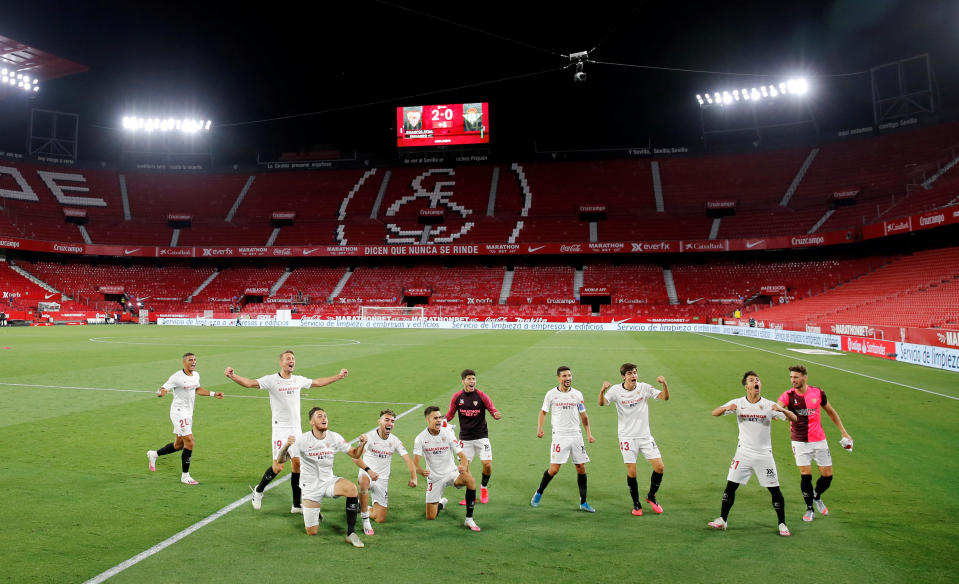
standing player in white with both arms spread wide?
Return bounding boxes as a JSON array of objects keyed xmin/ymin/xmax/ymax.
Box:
[{"xmin": 224, "ymin": 351, "xmax": 349, "ymax": 513}]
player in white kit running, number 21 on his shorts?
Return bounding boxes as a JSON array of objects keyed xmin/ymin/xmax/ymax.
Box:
[{"xmin": 147, "ymin": 353, "xmax": 223, "ymax": 485}]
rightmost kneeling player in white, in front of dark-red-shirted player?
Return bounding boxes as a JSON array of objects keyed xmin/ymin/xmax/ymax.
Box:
[{"xmin": 413, "ymin": 406, "xmax": 480, "ymax": 531}]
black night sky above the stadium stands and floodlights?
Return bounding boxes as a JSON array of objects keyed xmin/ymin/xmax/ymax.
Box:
[{"xmin": 0, "ymin": 0, "xmax": 959, "ymax": 159}]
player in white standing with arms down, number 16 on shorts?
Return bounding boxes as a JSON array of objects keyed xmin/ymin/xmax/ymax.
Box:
[{"xmin": 529, "ymin": 365, "xmax": 596, "ymax": 513}]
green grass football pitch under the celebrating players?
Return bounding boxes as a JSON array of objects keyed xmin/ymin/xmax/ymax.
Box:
[{"xmin": 0, "ymin": 326, "xmax": 959, "ymax": 584}]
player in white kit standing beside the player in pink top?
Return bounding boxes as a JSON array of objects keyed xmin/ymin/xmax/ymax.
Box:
[{"xmin": 708, "ymin": 371, "xmax": 796, "ymax": 535}]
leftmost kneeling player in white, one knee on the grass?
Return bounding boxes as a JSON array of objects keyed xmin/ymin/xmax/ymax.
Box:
[{"xmin": 296, "ymin": 408, "xmax": 366, "ymax": 547}]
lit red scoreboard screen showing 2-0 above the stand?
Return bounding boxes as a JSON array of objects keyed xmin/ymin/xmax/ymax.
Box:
[{"xmin": 396, "ymin": 101, "xmax": 489, "ymax": 148}]
